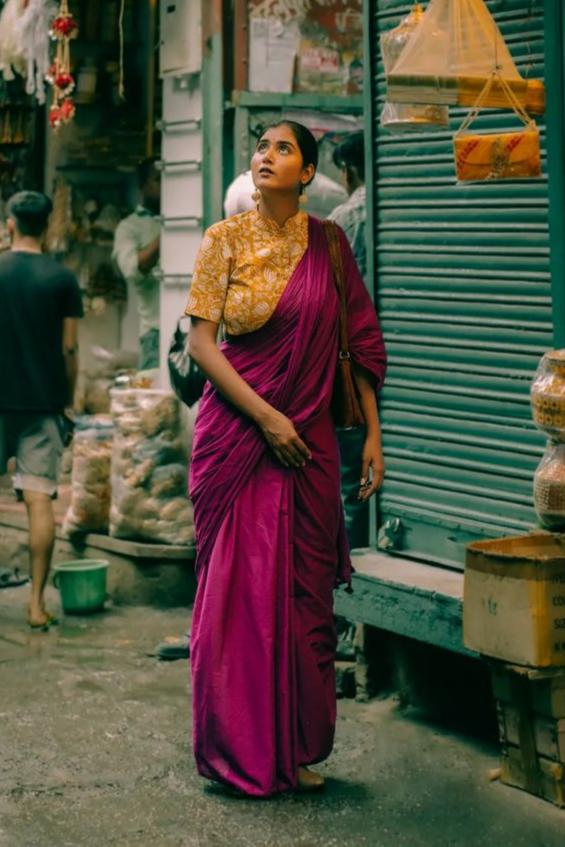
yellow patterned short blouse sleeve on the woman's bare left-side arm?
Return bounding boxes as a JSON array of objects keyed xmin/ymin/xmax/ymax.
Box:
[{"xmin": 185, "ymin": 227, "xmax": 231, "ymax": 323}]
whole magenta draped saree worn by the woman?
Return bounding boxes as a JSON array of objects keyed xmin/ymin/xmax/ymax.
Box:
[{"xmin": 189, "ymin": 218, "xmax": 385, "ymax": 796}]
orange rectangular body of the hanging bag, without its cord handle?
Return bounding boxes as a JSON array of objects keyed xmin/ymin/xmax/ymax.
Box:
[{"xmin": 454, "ymin": 125, "xmax": 541, "ymax": 182}]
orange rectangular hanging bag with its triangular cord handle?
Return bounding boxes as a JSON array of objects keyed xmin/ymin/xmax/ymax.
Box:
[{"xmin": 453, "ymin": 72, "xmax": 541, "ymax": 182}]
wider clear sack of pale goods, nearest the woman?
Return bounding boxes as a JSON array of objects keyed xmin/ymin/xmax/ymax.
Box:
[{"xmin": 110, "ymin": 388, "xmax": 194, "ymax": 546}]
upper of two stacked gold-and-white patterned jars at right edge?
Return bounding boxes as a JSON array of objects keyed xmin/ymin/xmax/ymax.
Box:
[{"xmin": 531, "ymin": 350, "xmax": 565, "ymax": 442}]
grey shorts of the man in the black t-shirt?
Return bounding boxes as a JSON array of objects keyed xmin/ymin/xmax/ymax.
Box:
[{"xmin": 0, "ymin": 412, "xmax": 64, "ymax": 498}]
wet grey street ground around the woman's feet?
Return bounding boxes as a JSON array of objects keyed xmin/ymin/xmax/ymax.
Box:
[{"xmin": 0, "ymin": 589, "xmax": 565, "ymax": 847}]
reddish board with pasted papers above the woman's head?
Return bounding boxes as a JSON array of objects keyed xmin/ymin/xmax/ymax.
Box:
[{"xmin": 248, "ymin": 0, "xmax": 363, "ymax": 96}]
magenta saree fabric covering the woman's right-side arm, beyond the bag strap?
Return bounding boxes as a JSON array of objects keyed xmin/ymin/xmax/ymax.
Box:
[{"xmin": 338, "ymin": 227, "xmax": 387, "ymax": 390}]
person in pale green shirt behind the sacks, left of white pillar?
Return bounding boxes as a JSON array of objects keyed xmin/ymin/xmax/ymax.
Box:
[{"xmin": 113, "ymin": 158, "xmax": 161, "ymax": 370}]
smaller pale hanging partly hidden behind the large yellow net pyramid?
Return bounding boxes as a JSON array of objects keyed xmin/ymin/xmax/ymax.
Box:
[{"xmin": 381, "ymin": 3, "xmax": 449, "ymax": 132}]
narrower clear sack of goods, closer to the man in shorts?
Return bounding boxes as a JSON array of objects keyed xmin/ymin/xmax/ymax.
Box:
[{"xmin": 63, "ymin": 415, "xmax": 114, "ymax": 535}]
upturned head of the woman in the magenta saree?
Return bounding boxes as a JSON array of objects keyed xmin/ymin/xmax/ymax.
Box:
[{"xmin": 251, "ymin": 124, "xmax": 315, "ymax": 193}]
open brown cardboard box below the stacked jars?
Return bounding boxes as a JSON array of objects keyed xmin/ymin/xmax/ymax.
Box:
[{"xmin": 463, "ymin": 533, "xmax": 565, "ymax": 667}]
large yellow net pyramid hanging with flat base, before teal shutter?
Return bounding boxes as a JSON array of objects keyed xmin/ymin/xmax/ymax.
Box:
[{"xmin": 387, "ymin": 0, "xmax": 545, "ymax": 114}]
